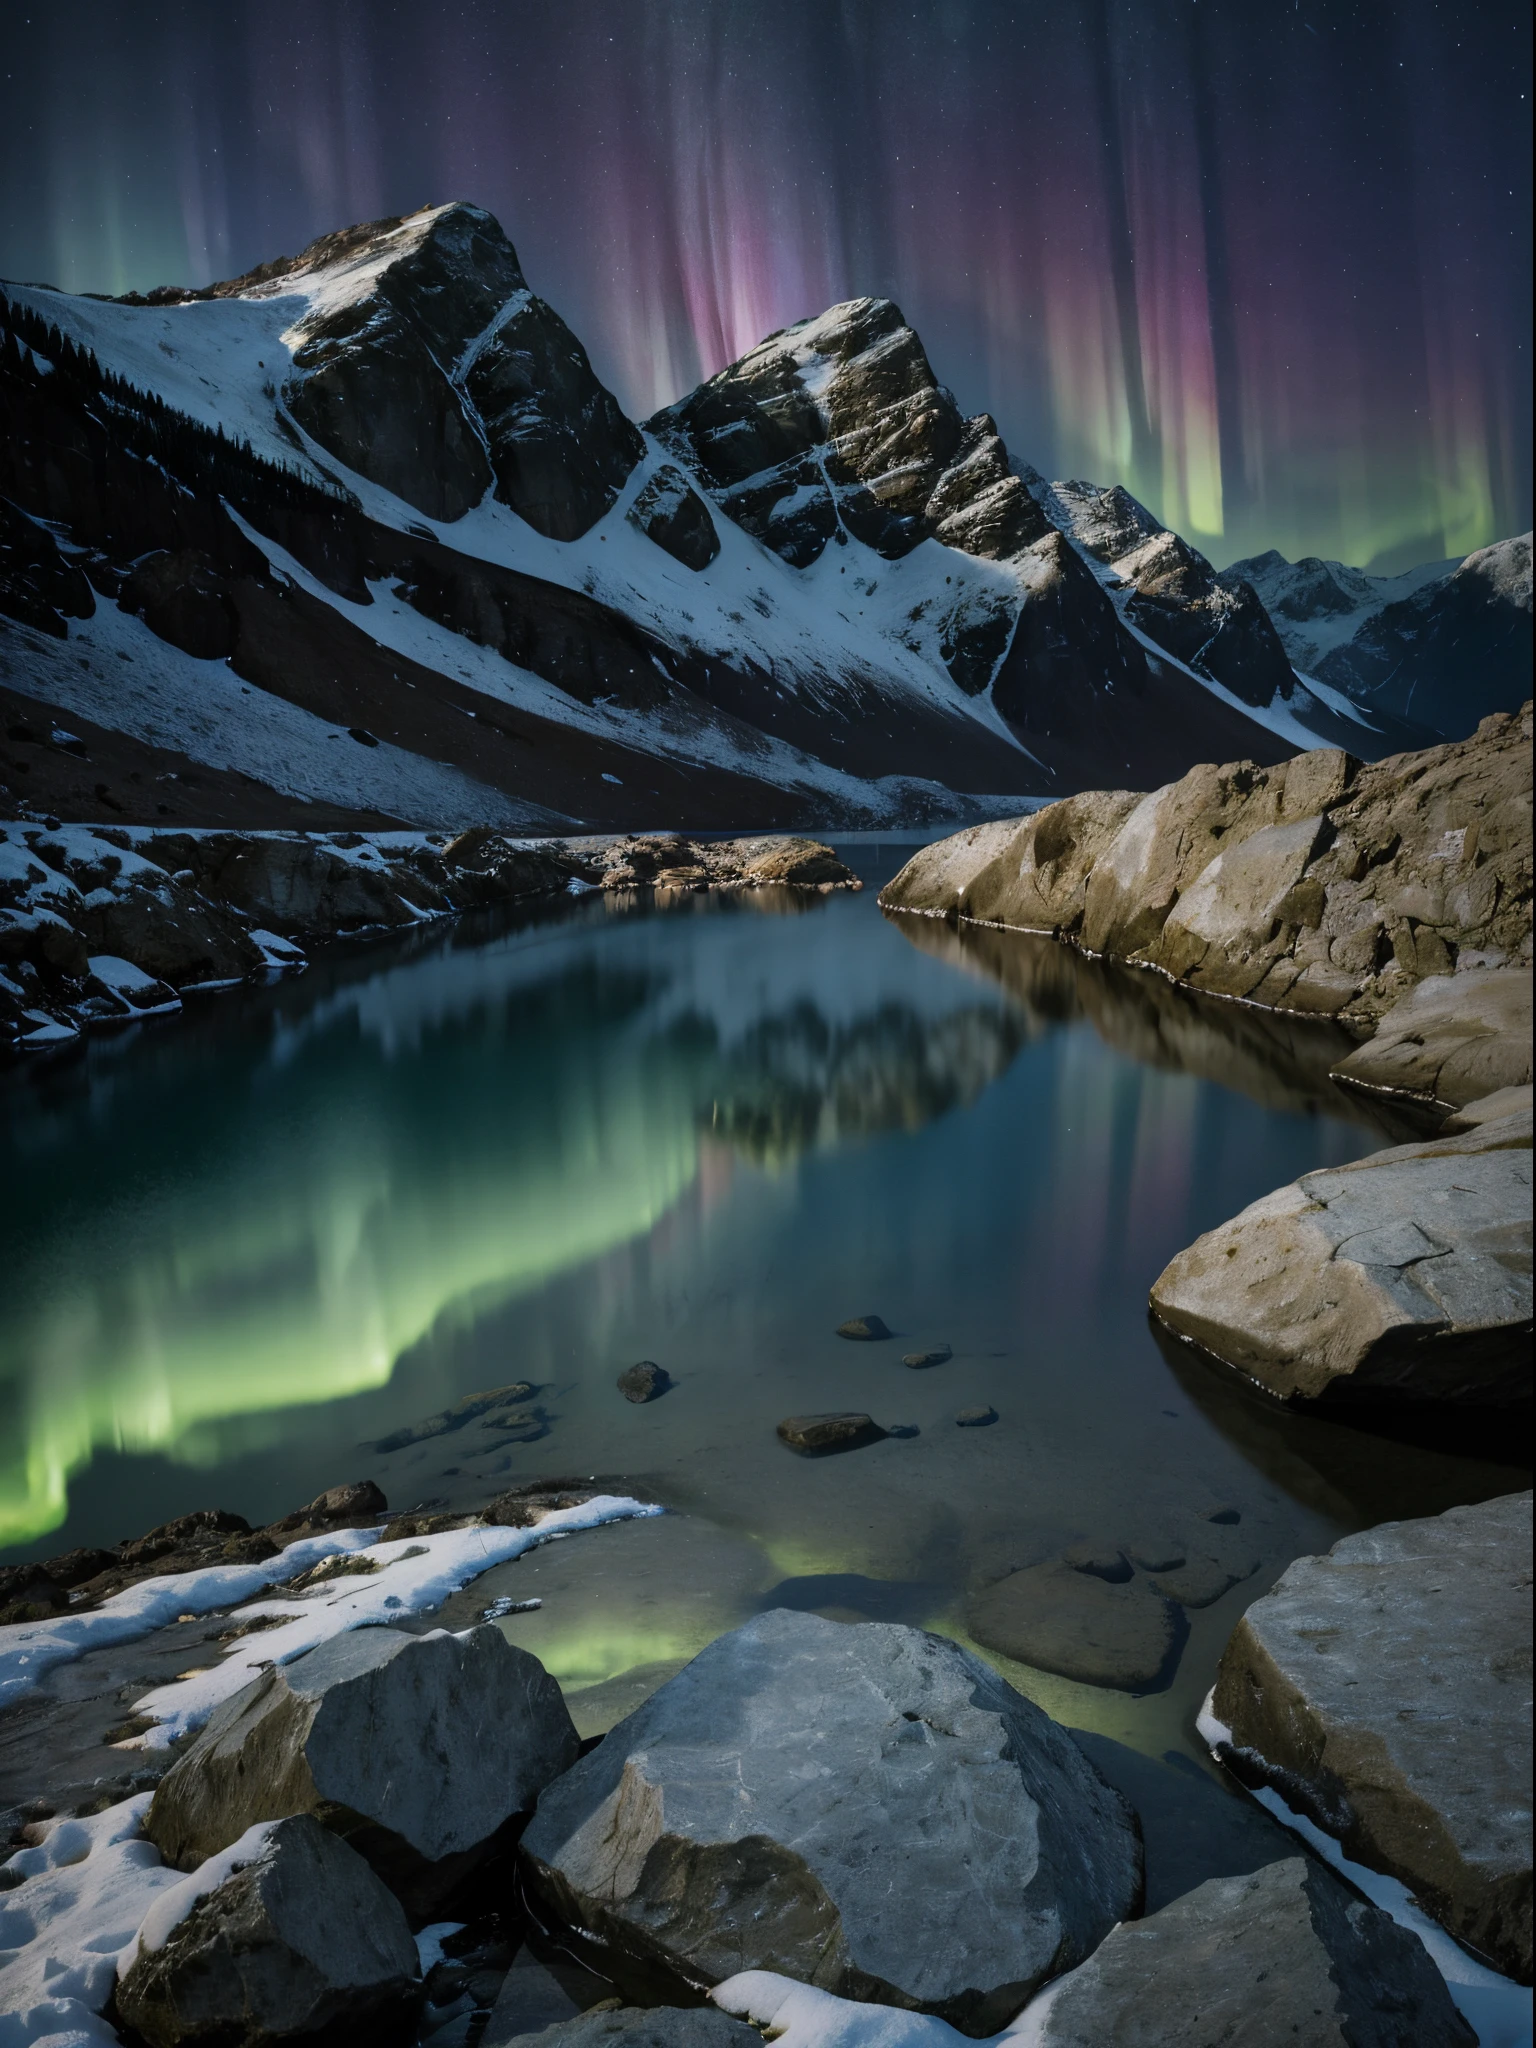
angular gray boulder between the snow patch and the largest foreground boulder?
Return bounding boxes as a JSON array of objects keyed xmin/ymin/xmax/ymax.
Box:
[{"xmin": 145, "ymin": 1626, "xmax": 580, "ymax": 1913}]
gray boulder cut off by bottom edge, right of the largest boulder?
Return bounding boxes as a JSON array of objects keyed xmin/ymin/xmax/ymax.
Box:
[{"xmin": 1026, "ymin": 1855, "xmax": 1477, "ymax": 2048}]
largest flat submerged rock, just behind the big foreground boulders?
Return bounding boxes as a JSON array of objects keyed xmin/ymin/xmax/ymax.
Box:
[{"xmin": 965, "ymin": 1559, "xmax": 1190, "ymax": 1692}]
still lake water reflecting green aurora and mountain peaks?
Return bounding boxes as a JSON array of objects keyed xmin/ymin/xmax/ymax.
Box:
[{"xmin": 0, "ymin": 844, "xmax": 1528, "ymax": 1875}]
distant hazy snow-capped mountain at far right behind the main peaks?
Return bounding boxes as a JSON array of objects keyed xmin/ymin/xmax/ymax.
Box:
[{"xmin": 1227, "ymin": 535, "xmax": 1532, "ymax": 739}]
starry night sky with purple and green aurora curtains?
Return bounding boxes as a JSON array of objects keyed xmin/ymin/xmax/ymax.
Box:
[{"xmin": 0, "ymin": 0, "xmax": 1532, "ymax": 567}]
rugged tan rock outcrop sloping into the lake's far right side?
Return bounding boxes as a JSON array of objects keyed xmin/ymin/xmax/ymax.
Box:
[{"xmin": 881, "ymin": 707, "xmax": 1532, "ymax": 1026}]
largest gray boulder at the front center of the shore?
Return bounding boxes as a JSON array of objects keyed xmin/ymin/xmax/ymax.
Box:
[{"xmin": 522, "ymin": 1610, "xmax": 1141, "ymax": 2034}]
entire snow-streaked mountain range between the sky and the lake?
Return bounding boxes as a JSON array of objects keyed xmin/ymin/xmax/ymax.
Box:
[{"xmin": 0, "ymin": 205, "xmax": 1530, "ymax": 829}]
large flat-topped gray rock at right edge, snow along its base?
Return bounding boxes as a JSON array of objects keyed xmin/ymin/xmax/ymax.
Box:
[{"xmin": 1212, "ymin": 1493, "xmax": 1532, "ymax": 1985}]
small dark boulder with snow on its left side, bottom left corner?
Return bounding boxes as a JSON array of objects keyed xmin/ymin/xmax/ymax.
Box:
[{"xmin": 117, "ymin": 1815, "xmax": 418, "ymax": 2048}]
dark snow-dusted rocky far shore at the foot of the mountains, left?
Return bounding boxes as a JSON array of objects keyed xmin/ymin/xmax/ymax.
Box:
[{"xmin": 0, "ymin": 819, "xmax": 862, "ymax": 1059}]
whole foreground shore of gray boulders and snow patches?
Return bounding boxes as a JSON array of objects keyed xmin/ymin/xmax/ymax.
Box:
[{"xmin": 0, "ymin": 1481, "xmax": 1530, "ymax": 2048}]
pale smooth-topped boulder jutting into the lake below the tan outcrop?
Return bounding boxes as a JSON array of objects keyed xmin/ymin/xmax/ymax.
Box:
[{"xmin": 1151, "ymin": 1112, "xmax": 1532, "ymax": 1407}]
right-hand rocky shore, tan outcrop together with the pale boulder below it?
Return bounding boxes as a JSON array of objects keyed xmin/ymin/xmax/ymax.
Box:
[{"xmin": 881, "ymin": 705, "xmax": 1532, "ymax": 1409}]
